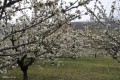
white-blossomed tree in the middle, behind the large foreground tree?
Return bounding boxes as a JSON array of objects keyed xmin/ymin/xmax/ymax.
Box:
[{"xmin": 46, "ymin": 24, "xmax": 84, "ymax": 59}]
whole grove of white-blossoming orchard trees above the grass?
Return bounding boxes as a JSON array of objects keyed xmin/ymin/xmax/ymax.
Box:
[{"xmin": 0, "ymin": 0, "xmax": 120, "ymax": 80}]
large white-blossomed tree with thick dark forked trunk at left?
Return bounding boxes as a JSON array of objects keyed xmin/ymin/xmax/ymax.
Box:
[{"xmin": 0, "ymin": 0, "xmax": 90, "ymax": 80}]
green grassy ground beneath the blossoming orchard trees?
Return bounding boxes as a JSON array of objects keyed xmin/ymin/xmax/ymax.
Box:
[{"xmin": 0, "ymin": 58, "xmax": 120, "ymax": 80}]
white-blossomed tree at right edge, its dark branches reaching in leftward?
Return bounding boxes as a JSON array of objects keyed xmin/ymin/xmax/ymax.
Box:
[{"xmin": 81, "ymin": 0, "xmax": 120, "ymax": 62}]
